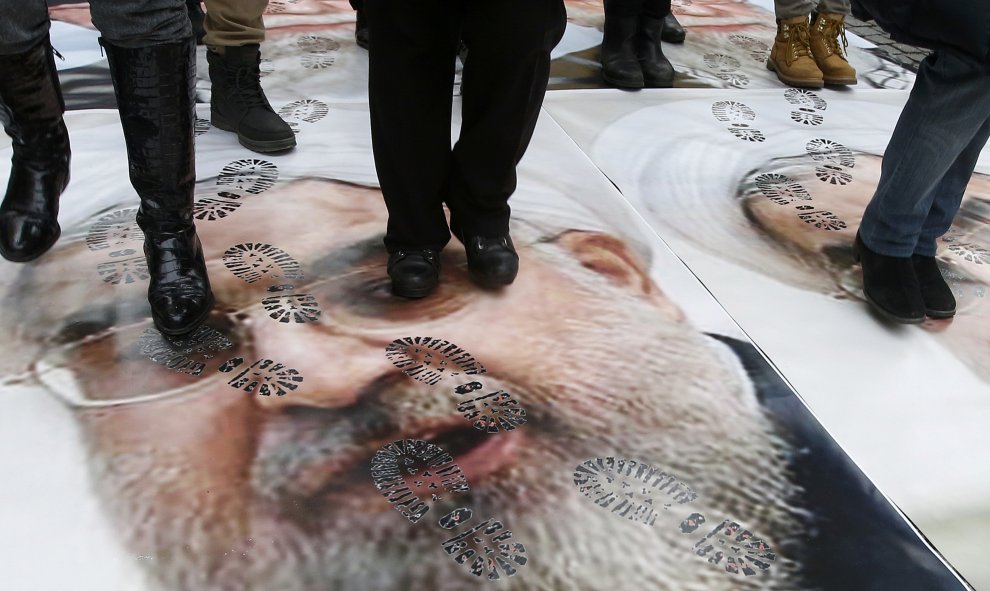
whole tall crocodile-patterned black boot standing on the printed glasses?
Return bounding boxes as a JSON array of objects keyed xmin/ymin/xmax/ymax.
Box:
[{"xmin": 101, "ymin": 38, "xmax": 213, "ymax": 335}]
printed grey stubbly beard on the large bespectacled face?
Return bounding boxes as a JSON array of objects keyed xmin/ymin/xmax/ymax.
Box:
[{"xmin": 85, "ymin": 250, "xmax": 807, "ymax": 591}]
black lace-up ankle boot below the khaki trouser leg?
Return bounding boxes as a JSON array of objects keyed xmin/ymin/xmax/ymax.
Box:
[{"xmin": 206, "ymin": 44, "xmax": 296, "ymax": 153}]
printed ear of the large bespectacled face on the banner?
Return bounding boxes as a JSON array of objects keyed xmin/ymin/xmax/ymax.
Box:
[{"xmin": 559, "ymin": 230, "xmax": 683, "ymax": 320}]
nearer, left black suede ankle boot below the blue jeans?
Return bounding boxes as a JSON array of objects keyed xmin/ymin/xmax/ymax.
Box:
[{"xmin": 853, "ymin": 233, "xmax": 925, "ymax": 324}]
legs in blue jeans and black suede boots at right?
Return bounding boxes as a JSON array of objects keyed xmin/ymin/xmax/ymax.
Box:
[{"xmin": 857, "ymin": 51, "xmax": 990, "ymax": 322}]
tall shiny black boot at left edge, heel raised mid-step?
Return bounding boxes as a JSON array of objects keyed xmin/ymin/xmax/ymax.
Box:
[{"xmin": 0, "ymin": 36, "xmax": 70, "ymax": 263}]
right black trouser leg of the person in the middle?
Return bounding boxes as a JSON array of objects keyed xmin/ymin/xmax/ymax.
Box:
[{"xmin": 447, "ymin": 0, "xmax": 566, "ymax": 237}]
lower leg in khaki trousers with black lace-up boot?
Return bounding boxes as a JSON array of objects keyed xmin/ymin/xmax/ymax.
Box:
[{"xmin": 204, "ymin": 0, "xmax": 296, "ymax": 153}]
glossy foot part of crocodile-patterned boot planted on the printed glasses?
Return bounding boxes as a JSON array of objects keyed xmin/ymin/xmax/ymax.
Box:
[{"xmin": 144, "ymin": 228, "xmax": 213, "ymax": 336}]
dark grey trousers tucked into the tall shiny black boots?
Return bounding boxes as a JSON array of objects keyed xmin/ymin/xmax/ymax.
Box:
[{"xmin": 0, "ymin": 0, "xmax": 192, "ymax": 55}]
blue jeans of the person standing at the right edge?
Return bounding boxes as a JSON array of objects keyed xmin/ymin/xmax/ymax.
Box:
[{"xmin": 859, "ymin": 50, "xmax": 990, "ymax": 257}]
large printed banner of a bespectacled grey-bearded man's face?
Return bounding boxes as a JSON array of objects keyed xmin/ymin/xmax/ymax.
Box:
[{"xmin": 0, "ymin": 0, "xmax": 967, "ymax": 591}]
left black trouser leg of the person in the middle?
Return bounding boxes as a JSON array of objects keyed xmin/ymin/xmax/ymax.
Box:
[{"xmin": 365, "ymin": 0, "xmax": 464, "ymax": 252}]
